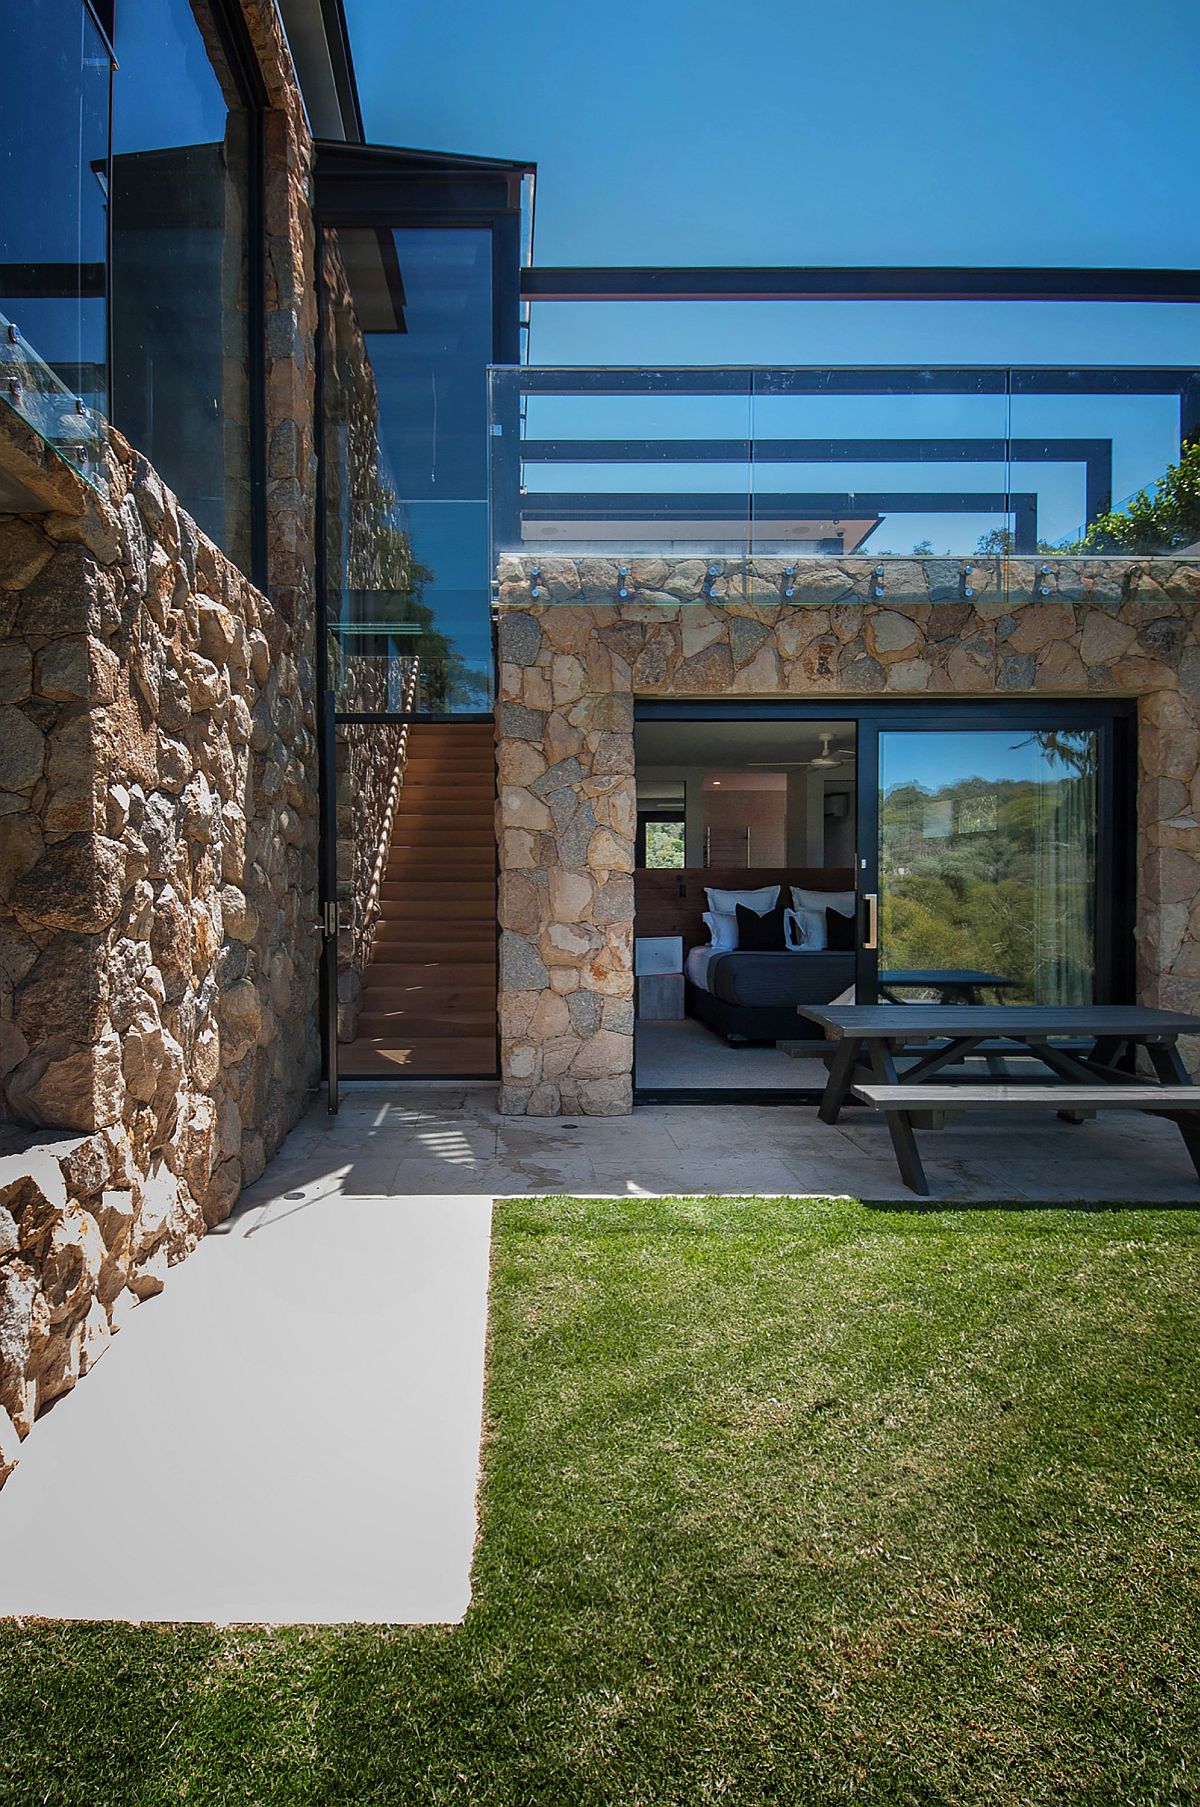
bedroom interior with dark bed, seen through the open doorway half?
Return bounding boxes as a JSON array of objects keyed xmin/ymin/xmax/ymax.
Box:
[{"xmin": 634, "ymin": 719, "xmax": 857, "ymax": 1095}]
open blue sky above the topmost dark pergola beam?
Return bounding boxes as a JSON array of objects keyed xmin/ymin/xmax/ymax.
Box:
[{"xmin": 347, "ymin": 0, "xmax": 1200, "ymax": 276}]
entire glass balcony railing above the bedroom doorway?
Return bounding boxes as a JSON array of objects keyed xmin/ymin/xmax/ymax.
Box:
[{"xmin": 490, "ymin": 365, "xmax": 1200, "ymax": 605}]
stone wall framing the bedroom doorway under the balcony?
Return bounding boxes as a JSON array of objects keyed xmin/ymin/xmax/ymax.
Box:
[{"xmin": 497, "ymin": 558, "xmax": 1200, "ymax": 1115}]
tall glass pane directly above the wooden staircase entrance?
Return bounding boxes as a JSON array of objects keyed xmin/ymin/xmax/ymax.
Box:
[{"xmin": 322, "ymin": 226, "xmax": 493, "ymax": 712}]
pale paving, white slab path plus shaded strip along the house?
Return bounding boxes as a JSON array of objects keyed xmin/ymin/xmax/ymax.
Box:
[{"xmin": 0, "ymin": 1084, "xmax": 1200, "ymax": 1624}]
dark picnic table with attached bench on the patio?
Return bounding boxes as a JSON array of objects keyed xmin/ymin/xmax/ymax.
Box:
[{"xmin": 799, "ymin": 1005, "xmax": 1200, "ymax": 1194}]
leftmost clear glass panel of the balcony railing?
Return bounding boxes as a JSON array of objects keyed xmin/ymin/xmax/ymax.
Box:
[{"xmin": 490, "ymin": 369, "xmax": 750, "ymax": 605}]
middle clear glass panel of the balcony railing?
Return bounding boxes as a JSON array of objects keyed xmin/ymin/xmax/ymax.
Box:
[{"xmin": 752, "ymin": 365, "xmax": 1012, "ymax": 604}]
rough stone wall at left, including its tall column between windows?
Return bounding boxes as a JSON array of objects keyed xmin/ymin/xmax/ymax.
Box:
[{"xmin": 0, "ymin": 0, "xmax": 320, "ymax": 1480}]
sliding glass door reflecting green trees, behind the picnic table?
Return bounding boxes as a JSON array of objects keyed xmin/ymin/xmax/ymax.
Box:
[{"xmin": 858, "ymin": 705, "xmax": 1130, "ymax": 1005}]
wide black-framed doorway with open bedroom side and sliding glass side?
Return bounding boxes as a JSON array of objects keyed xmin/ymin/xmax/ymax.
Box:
[{"xmin": 634, "ymin": 699, "xmax": 1135, "ymax": 1104}]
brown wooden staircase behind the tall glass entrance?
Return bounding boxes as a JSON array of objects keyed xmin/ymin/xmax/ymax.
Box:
[{"xmin": 342, "ymin": 723, "xmax": 495, "ymax": 1079}]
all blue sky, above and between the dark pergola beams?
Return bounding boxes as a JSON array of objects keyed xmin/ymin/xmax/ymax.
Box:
[{"xmin": 345, "ymin": 0, "xmax": 1200, "ymax": 551}]
